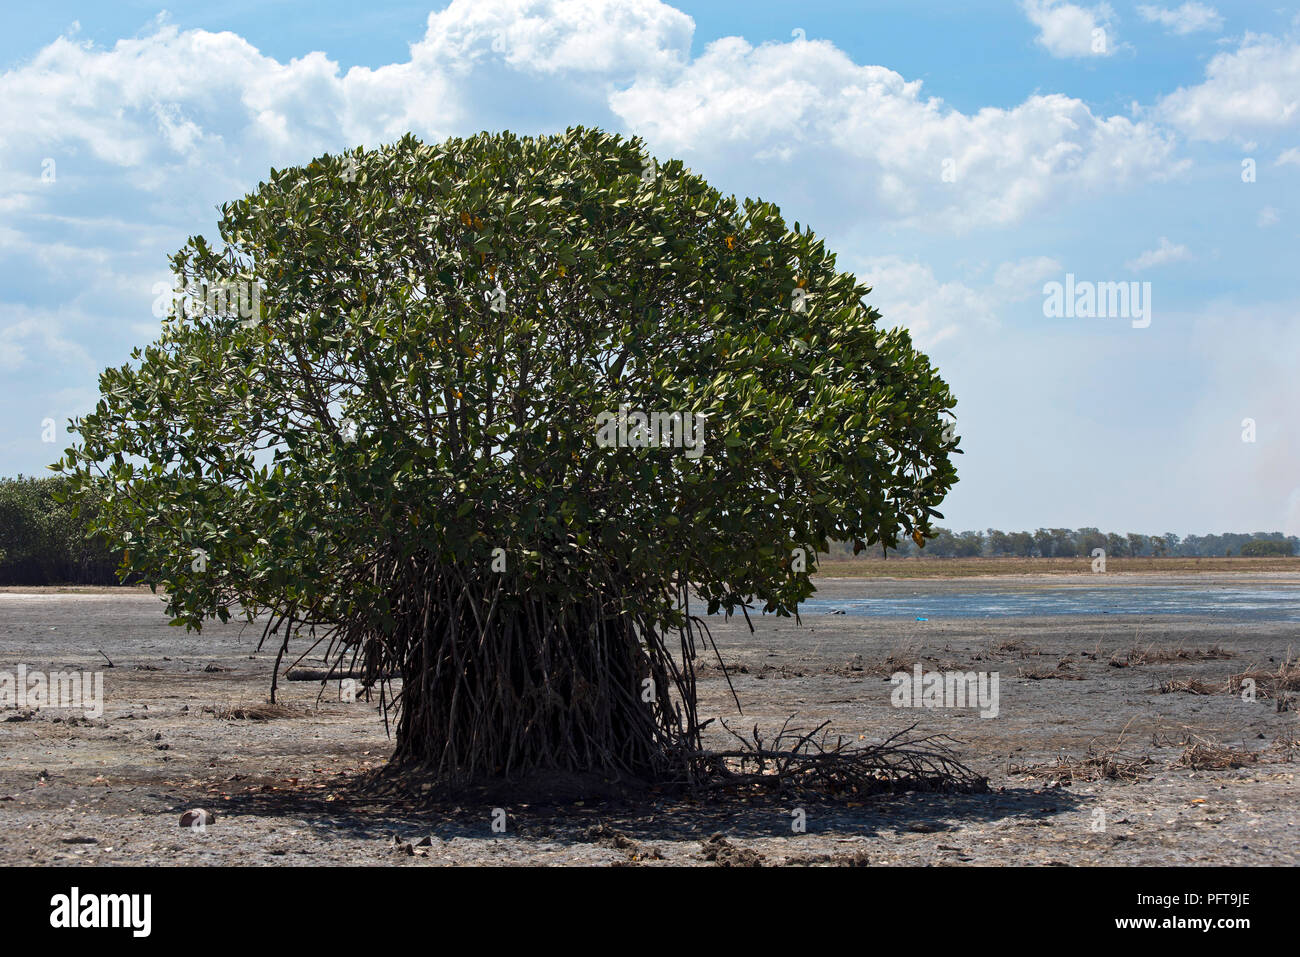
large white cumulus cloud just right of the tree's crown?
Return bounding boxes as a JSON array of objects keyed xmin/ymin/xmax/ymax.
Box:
[{"xmin": 610, "ymin": 36, "xmax": 1183, "ymax": 230}]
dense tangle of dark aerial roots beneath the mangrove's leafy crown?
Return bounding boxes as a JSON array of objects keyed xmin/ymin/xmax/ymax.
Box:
[{"xmin": 263, "ymin": 566, "xmax": 711, "ymax": 787}]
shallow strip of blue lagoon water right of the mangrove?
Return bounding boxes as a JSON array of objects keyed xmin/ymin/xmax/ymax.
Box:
[{"xmin": 800, "ymin": 583, "xmax": 1300, "ymax": 622}]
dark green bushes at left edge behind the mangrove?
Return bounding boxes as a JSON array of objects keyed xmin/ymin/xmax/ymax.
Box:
[{"xmin": 0, "ymin": 475, "xmax": 134, "ymax": 585}]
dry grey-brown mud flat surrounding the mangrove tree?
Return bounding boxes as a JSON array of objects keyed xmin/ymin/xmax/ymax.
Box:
[{"xmin": 0, "ymin": 575, "xmax": 1300, "ymax": 866}]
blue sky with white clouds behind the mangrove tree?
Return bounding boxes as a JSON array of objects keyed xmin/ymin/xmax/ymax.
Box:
[{"xmin": 0, "ymin": 0, "xmax": 1300, "ymax": 533}]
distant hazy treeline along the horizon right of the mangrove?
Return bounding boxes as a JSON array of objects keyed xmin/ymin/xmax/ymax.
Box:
[{"xmin": 829, "ymin": 528, "xmax": 1300, "ymax": 558}]
